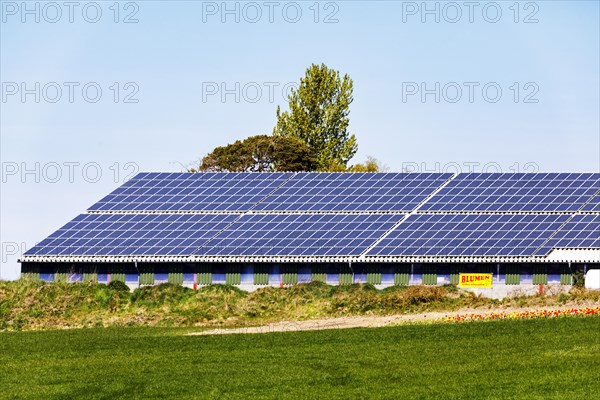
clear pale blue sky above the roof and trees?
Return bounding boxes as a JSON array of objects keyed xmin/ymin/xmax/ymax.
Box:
[{"xmin": 0, "ymin": 1, "xmax": 600, "ymax": 279}]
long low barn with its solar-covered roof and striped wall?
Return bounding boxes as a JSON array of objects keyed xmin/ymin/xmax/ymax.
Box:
[{"xmin": 20, "ymin": 172, "xmax": 600, "ymax": 289}]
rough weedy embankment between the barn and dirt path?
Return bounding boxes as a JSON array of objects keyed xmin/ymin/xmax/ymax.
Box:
[{"xmin": 0, "ymin": 281, "xmax": 600, "ymax": 331}]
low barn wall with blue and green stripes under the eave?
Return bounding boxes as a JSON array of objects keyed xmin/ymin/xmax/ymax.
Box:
[{"xmin": 22, "ymin": 263, "xmax": 600, "ymax": 288}]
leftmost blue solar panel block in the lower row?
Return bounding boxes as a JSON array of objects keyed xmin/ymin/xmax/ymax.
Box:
[{"xmin": 25, "ymin": 214, "xmax": 239, "ymax": 256}]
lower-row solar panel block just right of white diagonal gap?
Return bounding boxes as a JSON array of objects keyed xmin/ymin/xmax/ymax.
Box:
[{"xmin": 367, "ymin": 214, "xmax": 569, "ymax": 256}]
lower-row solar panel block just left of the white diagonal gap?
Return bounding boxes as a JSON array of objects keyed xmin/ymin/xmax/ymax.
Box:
[{"xmin": 196, "ymin": 214, "xmax": 402, "ymax": 256}]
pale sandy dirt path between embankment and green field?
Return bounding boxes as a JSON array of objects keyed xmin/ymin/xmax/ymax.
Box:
[{"xmin": 187, "ymin": 305, "xmax": 596, "ymax": 336}]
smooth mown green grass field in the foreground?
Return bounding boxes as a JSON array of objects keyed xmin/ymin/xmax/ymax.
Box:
[{"xmin": 0, "ymin": 317, "xmax": 600, "ymax": 400}]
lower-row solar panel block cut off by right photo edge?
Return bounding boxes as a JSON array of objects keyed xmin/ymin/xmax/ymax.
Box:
[{"xmin": 537, "ymin": 214, "xmax": 600, "ymax": 255}]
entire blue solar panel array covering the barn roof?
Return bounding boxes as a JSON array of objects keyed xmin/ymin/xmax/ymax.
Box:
[{"xmin": 25, "ymin": 173, "xmax": 600, "ymax": 259}]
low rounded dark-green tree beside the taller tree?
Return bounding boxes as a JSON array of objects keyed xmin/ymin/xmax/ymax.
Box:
[{"xmin": 190, "ymin": 135, "xmax": 316, "ymax": 172}]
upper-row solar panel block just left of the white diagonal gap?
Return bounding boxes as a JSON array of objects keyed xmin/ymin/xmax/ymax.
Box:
[{"xmin": 255, "ymin": 173, "xmax": 452, "ymax": 212}]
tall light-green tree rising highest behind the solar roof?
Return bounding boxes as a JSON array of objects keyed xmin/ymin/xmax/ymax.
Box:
[{"xmin": 273, "ymin": 64, "xmax": 358, "ymax": 171}]
